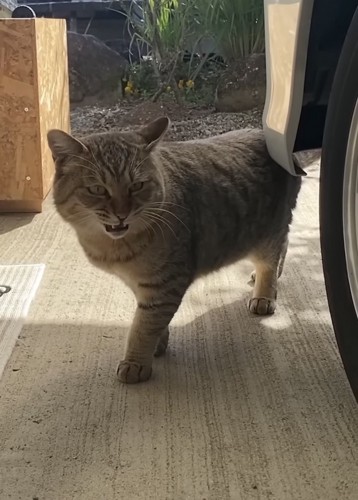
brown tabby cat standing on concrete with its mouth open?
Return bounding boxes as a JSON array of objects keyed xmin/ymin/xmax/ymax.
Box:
[{"xmin": 48, "ymin": 117, "xmax": 301, "ymax": 383}]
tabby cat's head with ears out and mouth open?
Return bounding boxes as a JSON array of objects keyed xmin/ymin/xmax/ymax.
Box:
[{"xmin": 48, "ymin": 118, "xmax": 169, "ymax": 239}]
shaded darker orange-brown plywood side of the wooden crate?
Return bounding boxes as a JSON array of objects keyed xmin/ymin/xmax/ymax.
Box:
[{"xmin": 0, "ymin": 19, "xmax": 42, "ymax": 204}]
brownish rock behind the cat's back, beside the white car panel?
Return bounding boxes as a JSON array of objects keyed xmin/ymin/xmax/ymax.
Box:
[{"xmin": 214, "ymin": 54, "xmax": 266, "ymax": 113}]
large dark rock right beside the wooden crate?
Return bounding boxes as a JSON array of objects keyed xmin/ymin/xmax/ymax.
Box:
[{"xmin": 67, "ymin": 31, "xmax": 128, "ymax": 103}]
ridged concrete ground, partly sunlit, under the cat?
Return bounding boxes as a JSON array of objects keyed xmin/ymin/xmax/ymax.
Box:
[{"xmin": 0, "ymin": 161, "xmax": 358, "ymax": 500}]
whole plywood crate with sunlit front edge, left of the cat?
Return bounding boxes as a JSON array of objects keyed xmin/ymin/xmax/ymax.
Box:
[{"xmin": 0, "ymin": 19, "xmax": 70, "ymax": 212}]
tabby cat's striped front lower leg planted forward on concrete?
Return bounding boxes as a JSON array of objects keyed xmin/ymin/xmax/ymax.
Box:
[{"xmin": 117, "ymin": 296, "xmax": 182, "ymax": 384}]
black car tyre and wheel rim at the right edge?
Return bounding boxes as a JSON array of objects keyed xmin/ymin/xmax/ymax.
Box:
[{"xmin": 320, "ymin": 9, "xmax": 358, "ymax": 401}]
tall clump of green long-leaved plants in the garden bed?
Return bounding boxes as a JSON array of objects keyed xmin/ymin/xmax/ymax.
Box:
[{"xmin": 122, "ymin": 0, "xmax": 264, "ymax": 101}]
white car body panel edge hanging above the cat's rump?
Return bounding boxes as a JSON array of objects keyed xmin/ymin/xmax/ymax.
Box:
[{"xmin": 263, "ymin": 0, "xmax": 314, "ymax": 175}]
